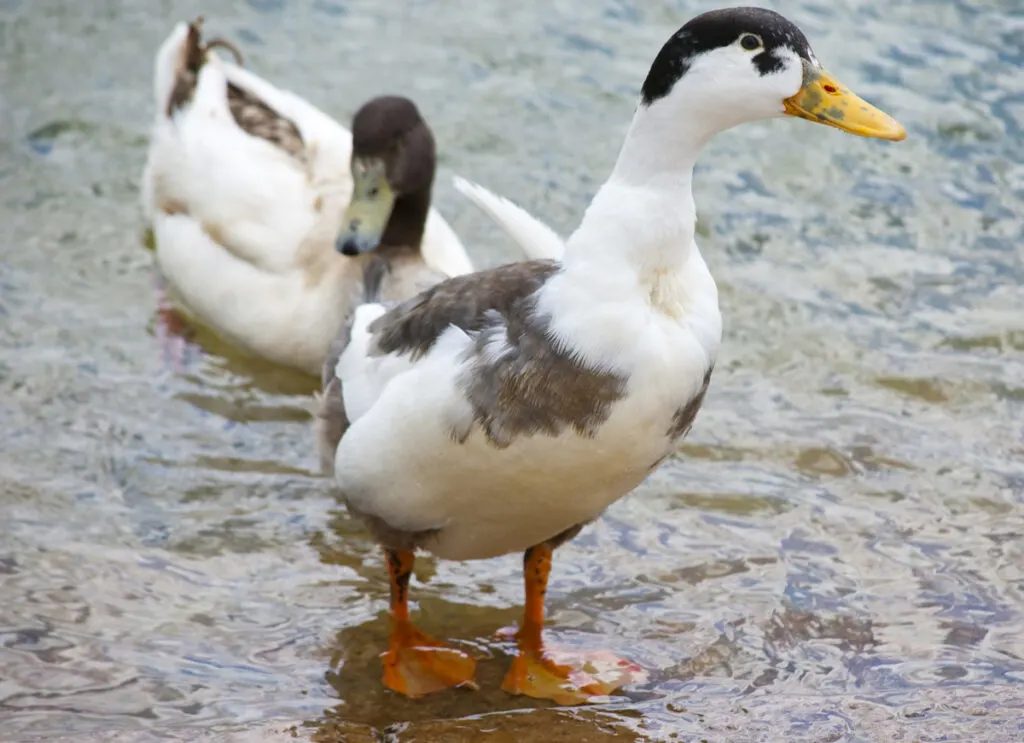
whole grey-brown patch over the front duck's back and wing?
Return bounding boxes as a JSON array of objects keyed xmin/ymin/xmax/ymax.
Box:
[{"xmin": 370, "ymin": 261, "xmax": 626, "ymax": 447}]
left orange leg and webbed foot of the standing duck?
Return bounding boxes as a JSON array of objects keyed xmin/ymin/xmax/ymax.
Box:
[{"xmin": 381, "ymin": 550, "xmax": 477, "ymax": 699}]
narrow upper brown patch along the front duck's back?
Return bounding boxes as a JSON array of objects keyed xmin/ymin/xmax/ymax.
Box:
[{"xmin": 370, "ymin": 260, "xmax": 558, "ymax": 358}]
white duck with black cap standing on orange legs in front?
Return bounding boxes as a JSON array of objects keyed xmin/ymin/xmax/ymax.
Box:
[{"xmin": 317, "ymin": 7, "xmax": 906, "ymax": 704}]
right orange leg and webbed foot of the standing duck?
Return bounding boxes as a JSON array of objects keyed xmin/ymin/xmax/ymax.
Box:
[{"xmin": 502, "ymin": 543, "xmax": 640, "ymax": 704}]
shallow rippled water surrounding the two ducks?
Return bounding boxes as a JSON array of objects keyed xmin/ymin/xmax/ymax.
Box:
[{"xmin": 0, "ymin": 0, "xmax": 1024, "ymax": 741}]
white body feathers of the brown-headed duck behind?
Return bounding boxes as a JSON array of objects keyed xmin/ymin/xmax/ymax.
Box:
[{"xmin": 141, "ymin": 24, "xmax": 473, "ymax": 374}]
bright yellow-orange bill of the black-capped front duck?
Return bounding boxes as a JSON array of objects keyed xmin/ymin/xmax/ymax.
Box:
[{"xmin": 783, "ymin": 60, "xmax": 906, "ymax": 142}]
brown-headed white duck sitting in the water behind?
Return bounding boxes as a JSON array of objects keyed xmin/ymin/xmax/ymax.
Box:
[{"xmin": 141, "ymin": 18, "xmax": 473, "ymax": 377}]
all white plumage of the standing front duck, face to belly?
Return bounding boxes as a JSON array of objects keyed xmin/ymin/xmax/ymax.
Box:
[{"xmin": 335, "ymin": 21, "xmax": 831, "ymax": 560}]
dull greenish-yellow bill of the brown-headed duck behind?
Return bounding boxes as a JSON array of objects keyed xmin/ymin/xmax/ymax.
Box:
[{"xmin": 335, "ymin": 158, "xmax": 395, "ymax": 256}]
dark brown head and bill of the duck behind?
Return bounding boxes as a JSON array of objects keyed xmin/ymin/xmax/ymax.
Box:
[{"xmin": 336, "ymin": 95, "xmax": 436, "ymax": 256}]
